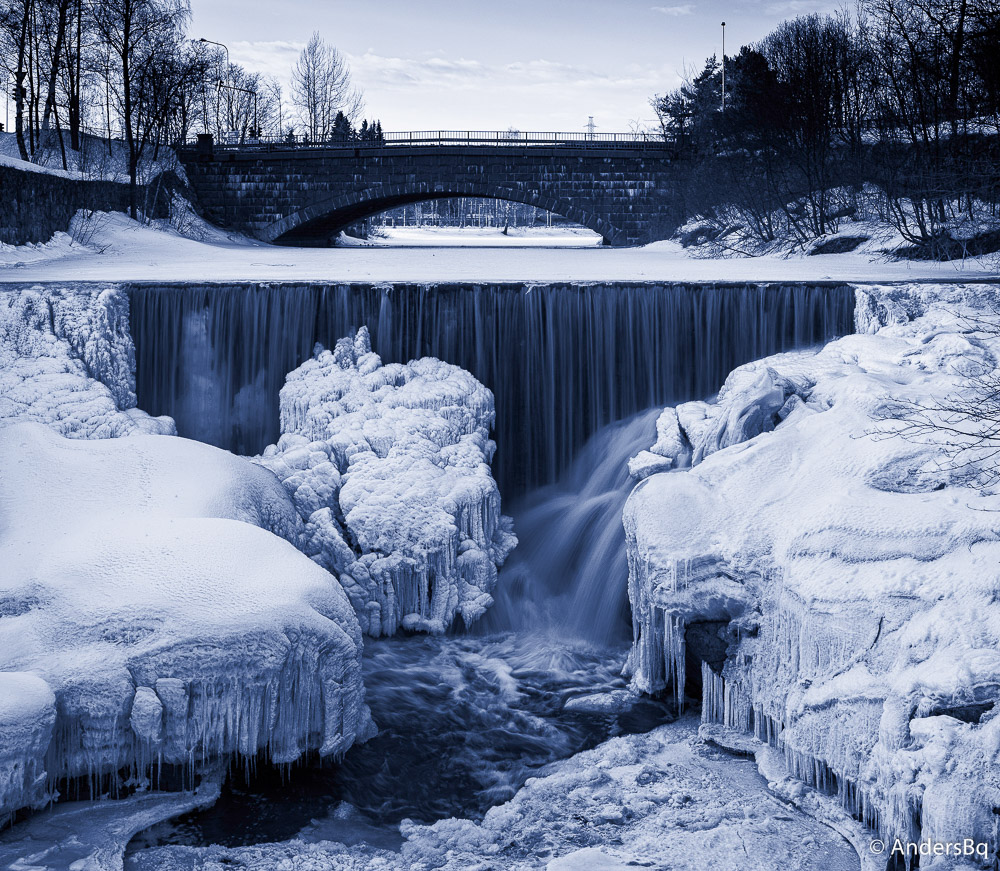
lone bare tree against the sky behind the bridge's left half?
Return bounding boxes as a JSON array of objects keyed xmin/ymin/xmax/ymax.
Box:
[{"xmin": 292, "ymin": 33, "xmax": 363, "ymax": 140}]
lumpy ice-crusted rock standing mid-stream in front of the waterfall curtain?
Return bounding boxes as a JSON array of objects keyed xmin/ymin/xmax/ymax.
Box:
[{"xmin": 258, "ymin": 328, "xmax": 516, "ymax": 636}]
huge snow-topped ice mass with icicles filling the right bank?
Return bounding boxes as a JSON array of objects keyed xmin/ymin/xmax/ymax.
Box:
[{"xmin": 624, "ymin": 285, "xmax": 1000, "ymax": 856}]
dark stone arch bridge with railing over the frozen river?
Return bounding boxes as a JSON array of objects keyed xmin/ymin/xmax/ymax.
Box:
[{"xmin": 180, "ymin": 133, "xmax": 683, "ymax": 246}]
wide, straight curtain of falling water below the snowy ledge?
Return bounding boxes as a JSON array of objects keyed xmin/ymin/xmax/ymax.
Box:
[{"xmin": 129, "ymin": 282, "xmax": 854, "ymax": 499}]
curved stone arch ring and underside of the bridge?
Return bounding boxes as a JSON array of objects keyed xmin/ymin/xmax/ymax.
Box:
[{"xmin": 266, "ymin": 182, "xmax": 624, "ymax": 245}]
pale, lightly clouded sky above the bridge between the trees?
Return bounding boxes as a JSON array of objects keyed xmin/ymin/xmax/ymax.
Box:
[{"xmin": 191, "ymin": 0, "xmax": 842, "ymax": 132}]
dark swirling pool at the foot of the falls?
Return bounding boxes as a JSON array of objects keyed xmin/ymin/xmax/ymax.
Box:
[{"xmin": 132, "ymin": 633, "xmax": 673, "ymax": 851}]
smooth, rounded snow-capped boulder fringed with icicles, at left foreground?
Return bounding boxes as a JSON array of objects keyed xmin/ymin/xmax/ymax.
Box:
[{"xmin": 0, "ymin": 423, "xmax": 371, "ymax": 816}]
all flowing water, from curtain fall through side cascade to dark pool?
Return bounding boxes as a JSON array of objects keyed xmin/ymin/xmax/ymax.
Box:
[{"xmin": 123, "ymin": 284, "xmax": 854, "ymax": 851}]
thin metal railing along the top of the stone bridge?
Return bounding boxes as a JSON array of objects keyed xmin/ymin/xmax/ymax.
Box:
[{"xmin": 184, "ymin": 130, "xmax": 670, "ymax": 151}]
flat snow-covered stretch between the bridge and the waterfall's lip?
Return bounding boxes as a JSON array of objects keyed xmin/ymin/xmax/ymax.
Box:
[{"xmin": 0, "ymin": 214, "xmax": 1000, "ymax": 283}]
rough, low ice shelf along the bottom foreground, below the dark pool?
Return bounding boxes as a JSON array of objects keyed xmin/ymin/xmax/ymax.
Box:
[{"xmin": 132, "ymin": 720, "xmax": 858, "ymax": 871}]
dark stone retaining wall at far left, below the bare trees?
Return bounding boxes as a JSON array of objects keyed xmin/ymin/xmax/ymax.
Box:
[{"xmin": 0, "ymin": 165, "xmax": 180, "ymax": 245}]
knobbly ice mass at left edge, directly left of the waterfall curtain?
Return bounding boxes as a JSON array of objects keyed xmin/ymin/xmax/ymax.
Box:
[{"xmin": 0, "ymin": 286, "xmax": 175, "ymax": 438}]
